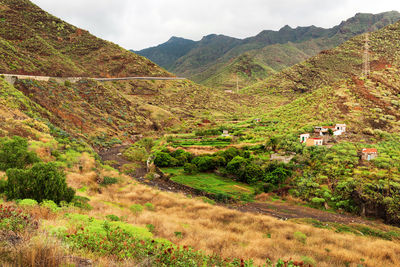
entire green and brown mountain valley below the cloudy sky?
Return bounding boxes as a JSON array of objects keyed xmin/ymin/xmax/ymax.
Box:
[{"xmin": 0, "ymin": 0, "xmax": 400, "ymax": 267}]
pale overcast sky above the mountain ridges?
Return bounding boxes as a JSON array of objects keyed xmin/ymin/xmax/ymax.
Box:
[{"xmin": 31, "ymin": 0, "xmax": 400, "ymax": 50}]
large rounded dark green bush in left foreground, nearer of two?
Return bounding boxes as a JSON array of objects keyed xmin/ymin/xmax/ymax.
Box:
[{"xmin": 6, "ymin": 162, "xmax": 75, "ymax": 204}]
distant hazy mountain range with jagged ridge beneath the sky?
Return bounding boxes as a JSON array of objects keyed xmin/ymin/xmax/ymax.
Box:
[{"xmin": 137, "ymin": 11, "xmax": 400, "ymax": 89}]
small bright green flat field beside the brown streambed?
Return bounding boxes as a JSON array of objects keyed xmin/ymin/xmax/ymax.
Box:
[{"xmin": 162, "ymin": 168, "xmax": 254, "ymax": 200}]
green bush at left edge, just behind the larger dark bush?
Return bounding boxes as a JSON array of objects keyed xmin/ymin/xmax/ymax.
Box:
[{"xmin": 0, "ymin": 136, "xmax": 40, "ymax": 171}]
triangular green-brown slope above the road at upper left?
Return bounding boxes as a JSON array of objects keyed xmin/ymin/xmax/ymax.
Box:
[{"xmin": 0, "ymin": 0, "xmax": 170, "ymax": 77}]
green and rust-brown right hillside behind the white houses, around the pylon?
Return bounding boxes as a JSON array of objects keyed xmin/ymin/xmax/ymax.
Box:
[{"xmin": 244, "ymin": 19, "xmax": 400, "ymax": 134}]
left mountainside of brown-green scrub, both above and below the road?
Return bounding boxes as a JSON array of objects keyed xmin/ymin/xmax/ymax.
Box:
[{"xmin": 0, "ymin": 0, "xmax": 251, "ymax": 146}]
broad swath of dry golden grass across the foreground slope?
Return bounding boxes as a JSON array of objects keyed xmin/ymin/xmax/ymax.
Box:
[{"xmin": 64, "ymin": 173, "xmax": 400, "ymax": 266}]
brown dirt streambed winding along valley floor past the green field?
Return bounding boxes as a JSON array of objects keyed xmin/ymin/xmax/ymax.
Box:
[{"xmin": 99, "ymin": 146, "xmax": 372, "ymax": 225}]
